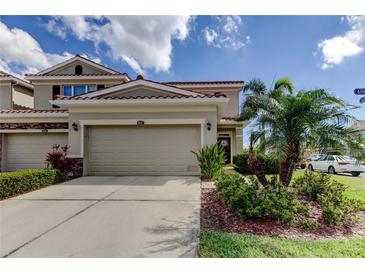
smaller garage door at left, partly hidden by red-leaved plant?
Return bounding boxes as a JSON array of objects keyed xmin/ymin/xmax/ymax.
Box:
[{"xmin": 5, "ymin": 133, "xmax": 68, "ymax": 171}]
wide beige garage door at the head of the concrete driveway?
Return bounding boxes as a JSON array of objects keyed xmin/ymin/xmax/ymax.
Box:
[{"xmin": 85, "ymin": 125, "xmax": 200, "ymax": 175}]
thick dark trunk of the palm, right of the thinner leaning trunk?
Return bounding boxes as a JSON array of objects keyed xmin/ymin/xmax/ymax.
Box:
[{"xmin": 279, "ymin": 141, "xmax": 299, "ymax": 186}]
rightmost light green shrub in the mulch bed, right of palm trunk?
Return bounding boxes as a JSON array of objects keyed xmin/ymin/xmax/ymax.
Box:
[{"xmin": 292, "ymin": 171, "xmax": 363, "ymax": 225}]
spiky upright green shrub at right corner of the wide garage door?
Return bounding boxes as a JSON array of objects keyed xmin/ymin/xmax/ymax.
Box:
[{"xmin": 192, "ymin": 143, "xmax": 226, "ymax": 179}]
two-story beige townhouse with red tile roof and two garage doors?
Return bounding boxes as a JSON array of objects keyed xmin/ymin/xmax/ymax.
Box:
[{"xmin": 0, "ymin": 55, "xmax": 245, "ymax": 175}]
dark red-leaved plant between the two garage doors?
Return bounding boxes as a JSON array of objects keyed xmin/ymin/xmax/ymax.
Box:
[{"xmin": 46, "ymin": 144, "xmax": 78, "ymax": 180}]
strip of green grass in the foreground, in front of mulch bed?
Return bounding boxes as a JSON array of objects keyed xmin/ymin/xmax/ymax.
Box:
[{"xmin": 200, "ymin": 230, "xmax": 365, "ymax": 258}]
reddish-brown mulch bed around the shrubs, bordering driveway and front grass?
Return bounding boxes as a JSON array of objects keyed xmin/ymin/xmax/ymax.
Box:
[{"xmin": 200, "ymin": 189, "xmax": 365, "ymax": 239}]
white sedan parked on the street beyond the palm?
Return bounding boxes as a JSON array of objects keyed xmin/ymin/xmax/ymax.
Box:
[{"xmin": 308, "ymin": 155, "xmax": 365, "ymax": 176}]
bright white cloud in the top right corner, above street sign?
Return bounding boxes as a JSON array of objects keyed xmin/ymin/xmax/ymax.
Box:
[{"xmin": 318, "ymin": 16, "xmax": 365, "ymax": 70}]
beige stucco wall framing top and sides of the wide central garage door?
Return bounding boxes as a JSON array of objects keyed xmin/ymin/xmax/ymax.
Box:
[{"xmin": 68, "ymin": 109, "xmax": 217, "ymax": 156}]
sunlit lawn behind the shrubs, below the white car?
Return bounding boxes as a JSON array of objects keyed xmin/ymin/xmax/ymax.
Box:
[{"xmin": 293, "ymin": 170, "xmax": 365, "ymax": 207}]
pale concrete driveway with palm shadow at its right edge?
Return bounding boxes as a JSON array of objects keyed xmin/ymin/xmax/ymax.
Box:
[{"xmin": 0, "ymin": 176, "xmax": 200, "ymax": 257}]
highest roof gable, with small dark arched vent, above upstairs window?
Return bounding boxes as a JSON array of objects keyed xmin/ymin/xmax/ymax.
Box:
[{"xmin": 28, "ymin": 55, "xmax": 124, "ymax": 76}]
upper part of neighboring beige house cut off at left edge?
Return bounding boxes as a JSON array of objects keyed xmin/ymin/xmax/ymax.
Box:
[{"xmin": 0, "ymin": 71, "xmax": 34, "ymax": 109}]
